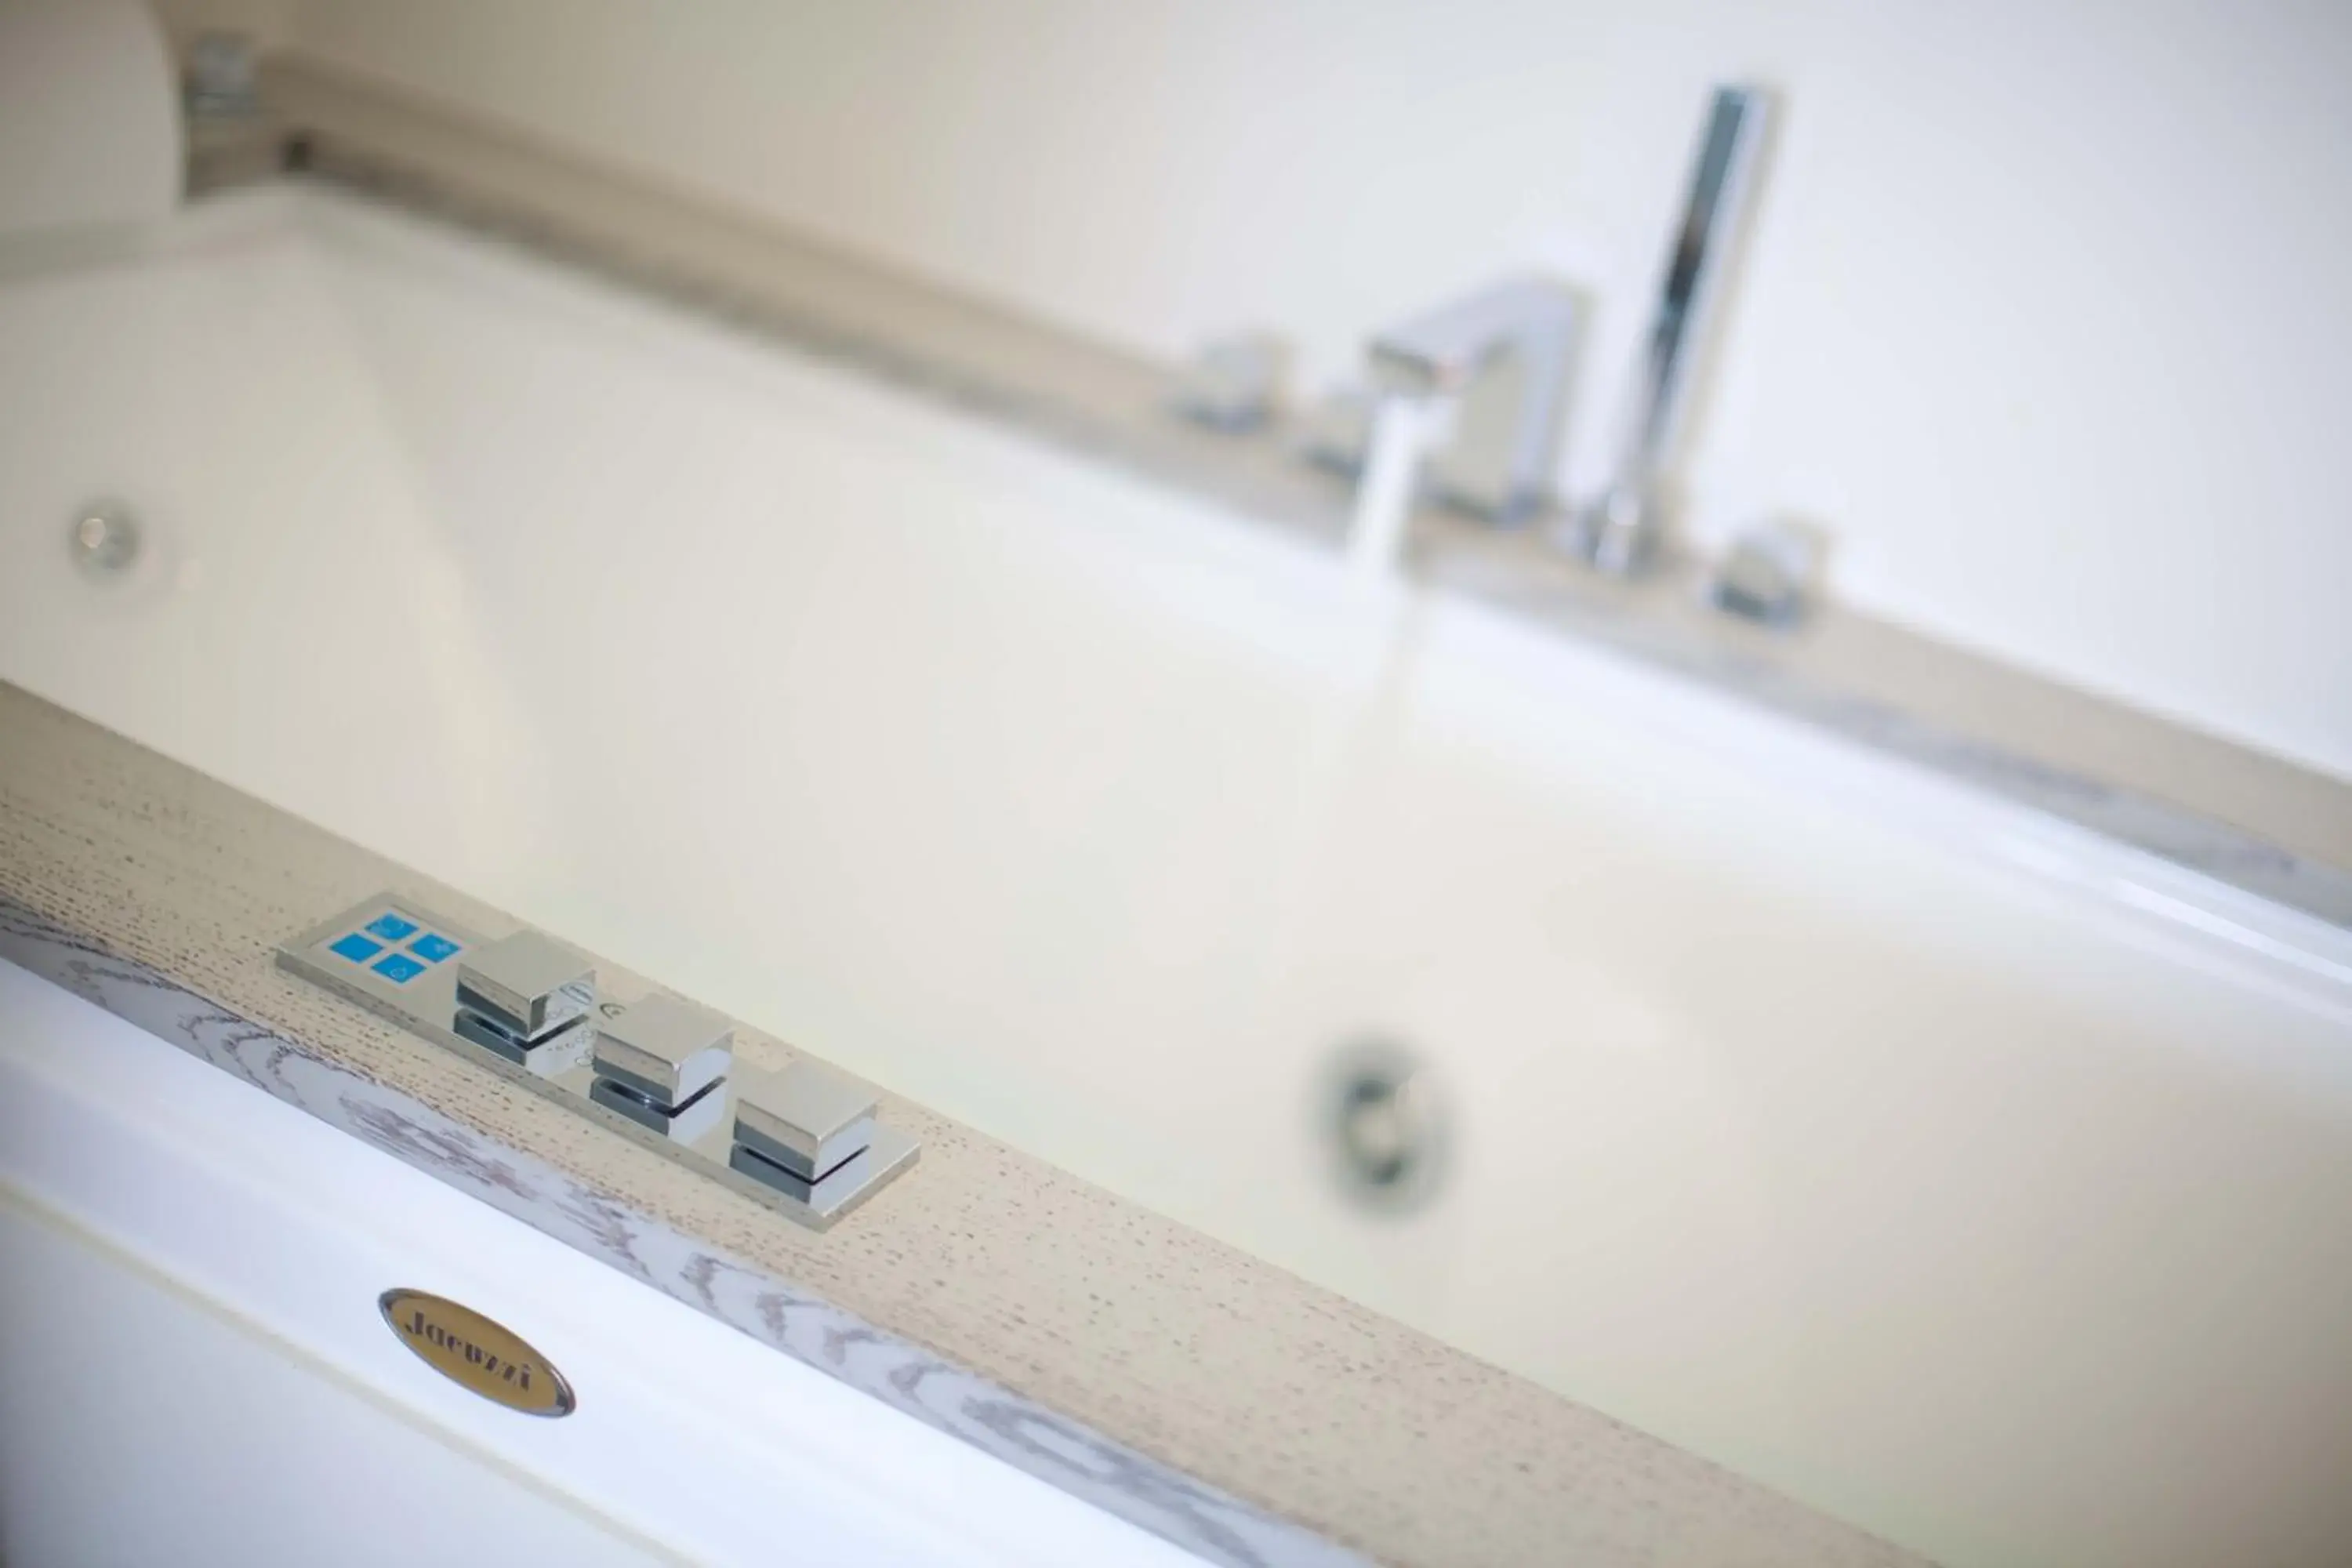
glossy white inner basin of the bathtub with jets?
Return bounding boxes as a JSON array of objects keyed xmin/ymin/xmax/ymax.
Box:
[{"xmin": 0, "ymin": 193, "xmax": 2352, "ymax": 1566}]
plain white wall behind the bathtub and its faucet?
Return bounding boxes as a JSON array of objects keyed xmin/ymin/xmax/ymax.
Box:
[{"xmin": 161, "ymin": 0, "xmax": 2352, "ymax": 779}]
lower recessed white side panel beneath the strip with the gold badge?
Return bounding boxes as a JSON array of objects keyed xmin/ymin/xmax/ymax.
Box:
[{"xmin": 0, "ymin": 1189, "xmax": 682, "ymax": 1568}]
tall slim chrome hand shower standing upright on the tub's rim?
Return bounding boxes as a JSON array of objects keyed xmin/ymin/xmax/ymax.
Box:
[{"xmin": 1566, "ymin": 87, "xmax": 1771, "ymax": 576}]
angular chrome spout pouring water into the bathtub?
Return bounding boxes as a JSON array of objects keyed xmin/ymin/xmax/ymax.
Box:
[{"xmin": 1371, "ymin": 278, "xmax": 1581, "ymax": 522}]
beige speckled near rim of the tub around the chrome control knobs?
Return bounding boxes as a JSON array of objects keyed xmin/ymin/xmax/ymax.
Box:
[{"xmin": 0, "ymin": 684, "xmax": 1917, "ymax": 1566}]
